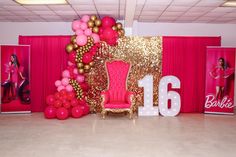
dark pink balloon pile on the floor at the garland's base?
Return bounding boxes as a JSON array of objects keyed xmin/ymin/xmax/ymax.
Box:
[{"xmin": 44, "ymin": 89, "xmax": 90, "ymax": 120}]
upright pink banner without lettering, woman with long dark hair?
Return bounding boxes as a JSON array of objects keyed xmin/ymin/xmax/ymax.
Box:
[{"xmin": 0, "ymin": 45, "xmax": 31, "ymax": 113}]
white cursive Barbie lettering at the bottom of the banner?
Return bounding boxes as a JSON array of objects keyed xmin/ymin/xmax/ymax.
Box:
[{"xmin": 205, "ymin": 95, "xmax": 234, "ymax": 108}]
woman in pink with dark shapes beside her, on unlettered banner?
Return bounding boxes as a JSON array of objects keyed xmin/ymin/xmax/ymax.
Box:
[{"xmin": 2, "ymin": 54, "xmax": 30, "ymax": 103}]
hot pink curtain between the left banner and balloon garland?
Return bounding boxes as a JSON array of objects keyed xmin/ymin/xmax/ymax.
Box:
[{"xmin": 19, "ymin": 36, "xmax": 70, "ymax": 112}]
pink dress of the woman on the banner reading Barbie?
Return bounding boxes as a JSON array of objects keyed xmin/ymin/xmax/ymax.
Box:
[{"xmin": 210, "ymin": 66, "xmax": 234, "ymax": 87}]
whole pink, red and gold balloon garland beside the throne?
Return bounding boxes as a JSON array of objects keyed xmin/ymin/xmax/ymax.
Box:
[{"xmin": 44, "ymin": 15, "xmax": 125, "ymax": 120}]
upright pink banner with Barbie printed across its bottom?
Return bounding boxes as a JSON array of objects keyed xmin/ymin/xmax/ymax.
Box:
[{"xmin": 205, "ymin": 47, "xmax": 236, "ymax": 114}]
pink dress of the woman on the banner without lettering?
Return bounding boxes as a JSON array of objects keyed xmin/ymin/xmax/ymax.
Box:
[{"xmin": 6, "ymin": 64, "xmax": 24, "ymax": 83}]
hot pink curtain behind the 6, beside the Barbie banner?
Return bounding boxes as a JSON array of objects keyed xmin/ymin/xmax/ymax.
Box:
[{"xmin": 162, "ymin": 36, "xmax": 221, "ymax": 113}]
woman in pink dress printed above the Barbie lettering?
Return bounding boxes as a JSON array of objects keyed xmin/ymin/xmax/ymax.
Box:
[{"xmin": 209, "ymin": 57, "xmax": 234, "ymax": 99}]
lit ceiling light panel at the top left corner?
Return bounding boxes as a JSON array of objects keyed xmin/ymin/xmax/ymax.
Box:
[{"xmin": 15, "ymin": 0, "xmax": 67, "ymax": 5}]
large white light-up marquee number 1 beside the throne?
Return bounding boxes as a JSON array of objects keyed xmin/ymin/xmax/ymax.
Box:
[{"xmin": 138, "ymin": 75, "xmax": 159, "ymax": 116}]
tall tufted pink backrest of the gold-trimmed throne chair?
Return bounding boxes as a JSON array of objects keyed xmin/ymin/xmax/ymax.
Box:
[{"xmin": 106, "ymin": 60, "xmax": 131, "ymax": 102}]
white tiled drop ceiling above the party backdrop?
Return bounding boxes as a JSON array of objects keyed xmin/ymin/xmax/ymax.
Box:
[{"xmin": 0, "ymin": 0, "xmax": 236, "ymax": 26}]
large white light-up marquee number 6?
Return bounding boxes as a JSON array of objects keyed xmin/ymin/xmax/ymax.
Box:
[{"xmin": 159, "ymin": 75, "xmax": 181, "ymax": 116}]
